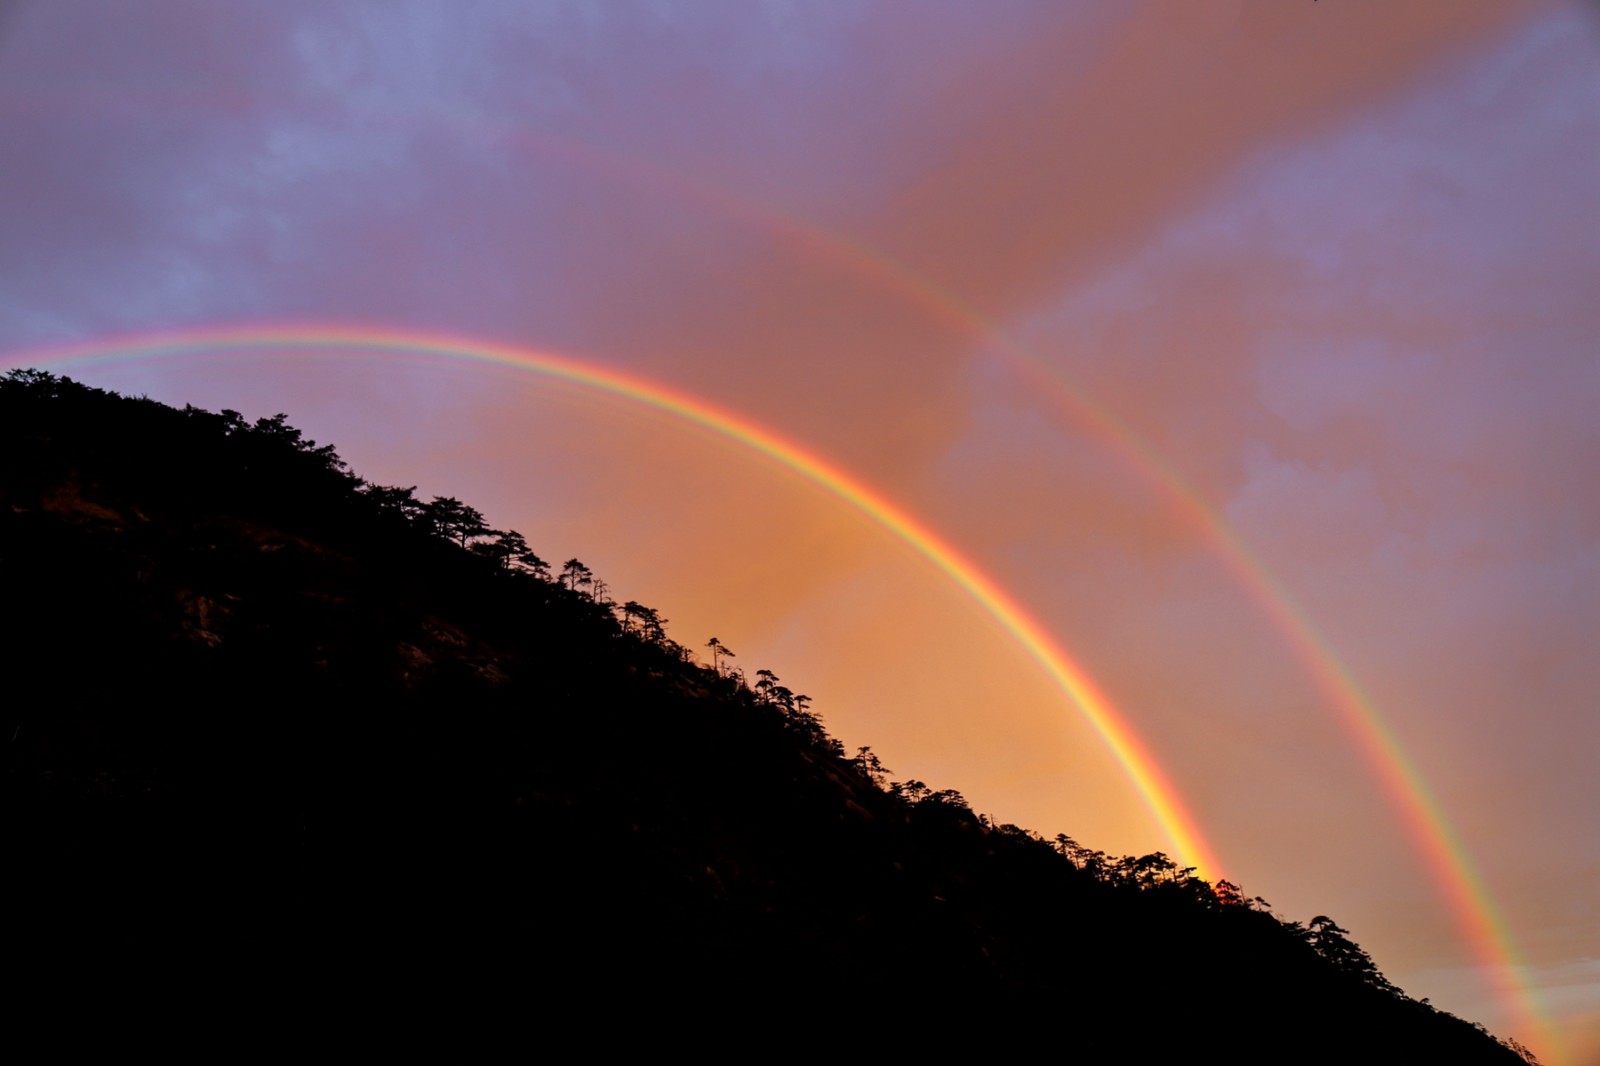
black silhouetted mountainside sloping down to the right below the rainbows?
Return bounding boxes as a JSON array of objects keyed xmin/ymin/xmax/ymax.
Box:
[{"xmin": 0, "ymin": 376, "xmax": 1520, "ymax": 1063}]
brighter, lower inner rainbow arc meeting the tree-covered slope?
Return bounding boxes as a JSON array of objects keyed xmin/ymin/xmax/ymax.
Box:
[{"xmin": 3, "ymin": 316, "xmax": 1222, "ymax": 879}]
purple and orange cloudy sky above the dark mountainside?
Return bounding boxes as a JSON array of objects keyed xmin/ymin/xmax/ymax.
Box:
[{"xmin": 0, "ymin": 0, "xmax": 1600, "ymax": 1066}]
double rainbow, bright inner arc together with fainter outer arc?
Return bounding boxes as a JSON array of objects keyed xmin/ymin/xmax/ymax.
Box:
[{"xmin": 18, "ymin": 68, "xmax": 1560, "ymax": 1055}]
